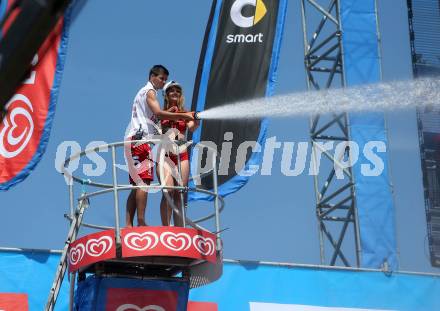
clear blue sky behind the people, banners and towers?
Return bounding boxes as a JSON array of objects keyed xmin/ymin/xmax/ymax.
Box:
[{"xmin": 0, "ymin": 0, "xmax": 438, "ymax": 271}]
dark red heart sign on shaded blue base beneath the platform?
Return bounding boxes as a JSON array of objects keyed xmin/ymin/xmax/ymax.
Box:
[{"xmin": 105, "ymin": 288, "xmax": 179, "ymax": 311}]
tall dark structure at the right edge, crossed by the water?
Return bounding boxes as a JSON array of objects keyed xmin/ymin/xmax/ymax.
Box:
[{"xmin": 408, "ymin": 0, "xmax": 440, "ymax": 267}]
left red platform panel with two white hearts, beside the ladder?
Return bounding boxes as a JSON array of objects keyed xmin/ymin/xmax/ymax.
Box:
[{"xmin": 68, "ymin": 230, "xmax": 116, "ymax": 272}]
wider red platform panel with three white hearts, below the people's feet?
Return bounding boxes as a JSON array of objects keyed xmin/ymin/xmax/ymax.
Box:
[{"xmin": 121, "ymin": 227, "xmax": 216, "ymax": 263}]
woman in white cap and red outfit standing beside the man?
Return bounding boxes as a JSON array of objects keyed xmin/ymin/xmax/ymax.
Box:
[{"xmin": 156, "ymin": 81, "xmax": 199, "ymax": 226}]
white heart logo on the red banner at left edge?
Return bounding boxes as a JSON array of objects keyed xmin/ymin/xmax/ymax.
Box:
[{"xmin": 0, "ymin": 94, "xmax": 34, "ymax": 158}]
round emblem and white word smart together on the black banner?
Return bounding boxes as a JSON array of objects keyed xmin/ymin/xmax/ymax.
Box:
[{"xmin": 226, "ymin": 0, "xmax": 267, "ymax": 43}]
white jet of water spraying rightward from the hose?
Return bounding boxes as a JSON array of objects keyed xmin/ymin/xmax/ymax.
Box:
[{"xmin": 199, "ymin": 78, "xmax": 440, "ymax": 119}]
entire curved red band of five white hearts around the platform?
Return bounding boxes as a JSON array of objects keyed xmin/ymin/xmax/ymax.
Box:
[{"xmin": 68, "ymin": 227, "xmax": 217, "ymax": 272}]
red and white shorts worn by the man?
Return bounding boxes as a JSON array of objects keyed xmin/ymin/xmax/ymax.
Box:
[{"xmin": 126, "ymin": 138, "xmax": 154, "ymax": 186}]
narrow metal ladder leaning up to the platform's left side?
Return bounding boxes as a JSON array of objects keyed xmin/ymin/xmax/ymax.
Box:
[{"xmin": 44, "ymin": 199, "xmax": 89, "ymax": 311}]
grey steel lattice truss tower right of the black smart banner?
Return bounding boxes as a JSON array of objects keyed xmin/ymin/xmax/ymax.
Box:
[{"xmin": 301, "ymin": 0, "xmax": 361, "ymax": 267}]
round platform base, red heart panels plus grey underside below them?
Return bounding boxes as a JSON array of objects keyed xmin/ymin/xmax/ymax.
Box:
[{"xmin": 68, "ymin": 227, "xmax": 222, "ymax": 287}]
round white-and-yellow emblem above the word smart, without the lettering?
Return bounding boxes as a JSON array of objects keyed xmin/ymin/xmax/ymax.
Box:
[{"xmin": 231, "ymin": 0, "xmax": 267, "ymax": 28}]
